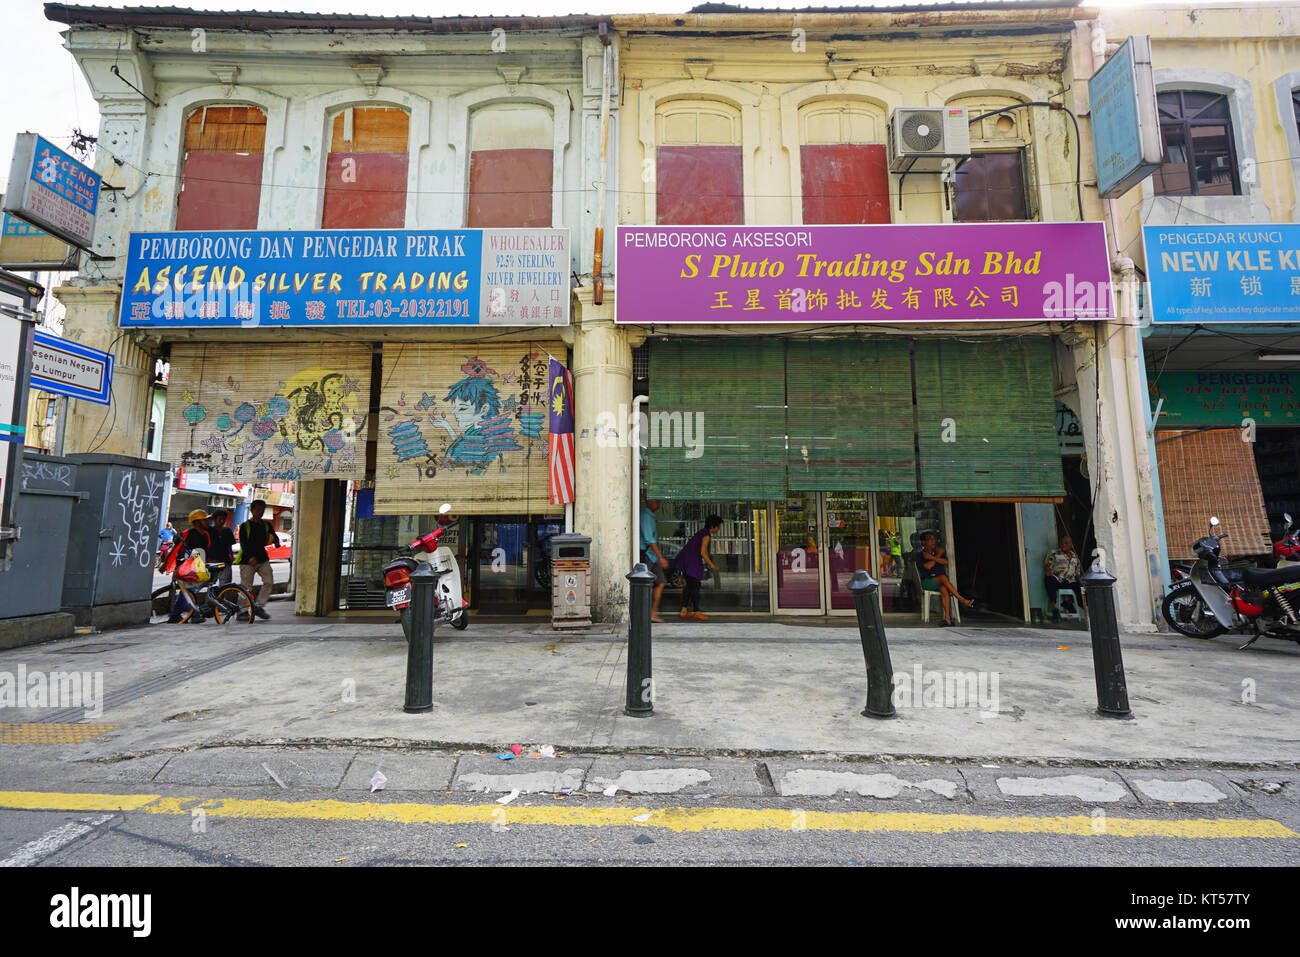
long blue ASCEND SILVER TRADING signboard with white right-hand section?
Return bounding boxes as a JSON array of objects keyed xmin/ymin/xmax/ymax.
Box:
[{"xmin": 121, "ymin": 229, "xmax": 571, "ymax": 329}]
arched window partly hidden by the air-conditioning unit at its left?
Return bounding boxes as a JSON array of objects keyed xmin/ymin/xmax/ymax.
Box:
[{"xmin": 948, "ymin": 96, "xmax": 1034, "ymax": 222}]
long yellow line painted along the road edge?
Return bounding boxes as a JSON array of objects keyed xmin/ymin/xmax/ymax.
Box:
[{"xmin": 0, "ymin": 791, "xmax": 1300, "ymax": 839}]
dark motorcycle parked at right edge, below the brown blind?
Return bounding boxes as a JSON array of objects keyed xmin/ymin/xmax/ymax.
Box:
[{"xmin": 1161, "ymin": 518, "xmax": 1300, "ymax": 649}]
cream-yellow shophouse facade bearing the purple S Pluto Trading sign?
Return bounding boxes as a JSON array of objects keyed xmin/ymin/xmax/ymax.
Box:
[{"xmin": 614, "ymin": 7, "xmax": 1160, "ymax": 627}]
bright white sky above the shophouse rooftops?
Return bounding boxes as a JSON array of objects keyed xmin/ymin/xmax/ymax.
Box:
[{"xmin": 0, "ymin": 0, "xmax": 1227, "ymax": 192}]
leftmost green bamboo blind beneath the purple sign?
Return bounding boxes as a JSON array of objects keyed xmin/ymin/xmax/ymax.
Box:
[{"xmin": 642, "ymin": 339, "xmax": 785, "ymax": 502}]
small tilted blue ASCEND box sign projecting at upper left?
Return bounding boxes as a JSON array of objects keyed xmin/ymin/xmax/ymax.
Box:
[{"xmin": 4, "ymin": 133, "xmax": 100, "ymax": 250}]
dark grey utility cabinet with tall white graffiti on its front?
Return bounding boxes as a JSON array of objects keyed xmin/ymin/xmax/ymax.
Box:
[{"xmin": 62, "ymin": 454, "xmax": 168, "ymax": 628}]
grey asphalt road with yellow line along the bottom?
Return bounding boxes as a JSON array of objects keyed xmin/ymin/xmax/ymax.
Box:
[{"xmin": 0, "ymin": 746, "xmax": 1300, "ymax": 867}]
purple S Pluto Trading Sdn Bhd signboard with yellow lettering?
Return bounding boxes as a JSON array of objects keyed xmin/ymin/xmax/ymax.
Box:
[{"xmin": 615, "ymin": 222, "xmax": 1114, "ymax": 325}]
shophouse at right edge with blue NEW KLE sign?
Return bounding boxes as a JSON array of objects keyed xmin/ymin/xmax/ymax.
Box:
[{"xmin": 1097, "ymin": 4, "xmax": 1300, "ymax": 564}]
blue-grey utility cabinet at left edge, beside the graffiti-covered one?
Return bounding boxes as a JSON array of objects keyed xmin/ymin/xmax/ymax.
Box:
[{"xmin": 0, "ymin": 451, "xmax": 86, "ymax": 648}]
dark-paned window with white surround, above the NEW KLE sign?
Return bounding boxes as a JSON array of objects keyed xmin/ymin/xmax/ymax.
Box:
[{"xmin": 1152, "ymin": 90, "xmax": 1242, "ymax": 196}]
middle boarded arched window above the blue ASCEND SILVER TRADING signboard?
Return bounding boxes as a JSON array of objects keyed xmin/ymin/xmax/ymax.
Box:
[{"xmin": 321, "ymin": 107, "xmax": 410, "ymax": 229}]
